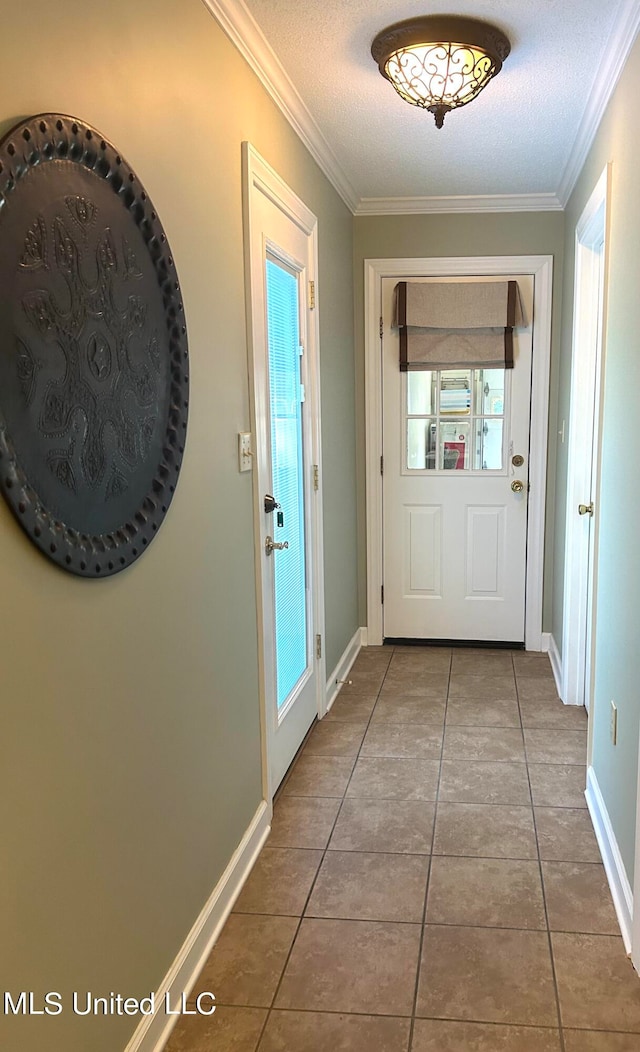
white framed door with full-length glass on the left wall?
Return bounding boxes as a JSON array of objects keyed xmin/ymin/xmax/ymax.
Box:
[{"xmin": 245, "ymin": 146, "xmax": 324, "ymax": 798}]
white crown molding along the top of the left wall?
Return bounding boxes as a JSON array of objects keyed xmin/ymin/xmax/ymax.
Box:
[{"xmin": 202, "ymin": 0, "xmax": 358, "ymax": 213}]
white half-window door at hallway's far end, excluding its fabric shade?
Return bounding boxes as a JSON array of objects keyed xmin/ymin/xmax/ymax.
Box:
[{"xmin": 382, "ymin": 275, "xmax": 534, "ymax": 644}]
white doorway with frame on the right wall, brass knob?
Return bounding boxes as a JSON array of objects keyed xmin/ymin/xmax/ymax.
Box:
[{"xmin": 561, "ymin": 165, "xmax": 611, "ymax": 715}]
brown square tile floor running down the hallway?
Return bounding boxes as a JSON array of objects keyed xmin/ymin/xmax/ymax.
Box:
[{"xmin": 166, "ymin": 647, "xmax": 640, "ymax": 1052}]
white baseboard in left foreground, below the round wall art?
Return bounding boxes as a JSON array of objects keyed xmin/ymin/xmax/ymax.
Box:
[{"xmin": 124, "ymin": 801, "xmax": 272, "ymax": 1052}]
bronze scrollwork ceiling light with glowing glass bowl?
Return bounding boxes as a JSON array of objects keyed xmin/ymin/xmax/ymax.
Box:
[{"xmin": 372, "ymin": 15, "xmax": 512, "ymax": 128}]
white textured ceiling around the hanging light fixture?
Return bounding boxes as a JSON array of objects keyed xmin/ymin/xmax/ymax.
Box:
[{"xmin": 210, "ymin": 0, "xmax": 640, "ymax": 213}]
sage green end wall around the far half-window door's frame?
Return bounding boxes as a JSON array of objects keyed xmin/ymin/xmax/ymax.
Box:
[{"xmin": 354, "ymin": 211, "xmax": 564, "ymax": 631}]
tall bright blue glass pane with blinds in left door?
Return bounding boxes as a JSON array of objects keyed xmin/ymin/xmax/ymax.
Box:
[{"xmin": 266, "ymin": 260, "xmax": 307, "ymax": 709}]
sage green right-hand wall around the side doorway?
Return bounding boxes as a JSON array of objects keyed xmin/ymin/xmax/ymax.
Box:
[{"xmin": 553, "ymin": 32, "xmax": 640, "ymax": 887}]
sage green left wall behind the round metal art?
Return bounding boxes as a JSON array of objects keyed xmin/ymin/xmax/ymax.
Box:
[{"xmin": 0, "ymin": 0, "xmax": 358, "ymax": 1052}]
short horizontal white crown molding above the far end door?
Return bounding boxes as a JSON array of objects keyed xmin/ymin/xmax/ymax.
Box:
[{"xmin": 355, "ymin": 194, "xmax": 562, "ymax": 216}]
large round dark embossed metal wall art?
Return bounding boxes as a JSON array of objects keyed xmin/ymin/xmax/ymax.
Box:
[{"xmin": 0, "ymin": 114, "xmax": 188, "ymax": 578}]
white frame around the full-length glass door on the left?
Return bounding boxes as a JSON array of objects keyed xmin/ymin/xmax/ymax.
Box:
[{"xmin": 242, "ymin": 142, "xmax": 326, "ymax": 804}]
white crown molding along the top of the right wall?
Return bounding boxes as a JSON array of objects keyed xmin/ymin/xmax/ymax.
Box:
[{"xmin": 558, "ymin": 0, "xmax": 640, "ymax": 208}]
